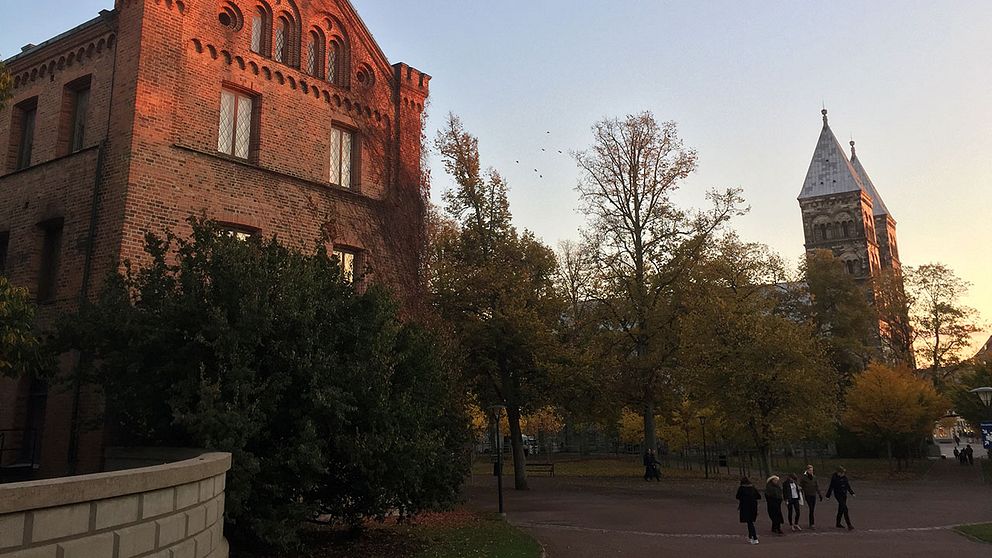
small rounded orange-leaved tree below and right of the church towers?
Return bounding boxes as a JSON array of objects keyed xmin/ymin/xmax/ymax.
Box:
[{"xmin": 844, "ymin": 363, "xmax": 947, "ymax": 467}]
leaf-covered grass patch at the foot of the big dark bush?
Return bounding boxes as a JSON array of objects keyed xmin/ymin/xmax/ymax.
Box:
[{"xmin": 231, "ymin": 510, "xmax": 541, "ymax": 558}]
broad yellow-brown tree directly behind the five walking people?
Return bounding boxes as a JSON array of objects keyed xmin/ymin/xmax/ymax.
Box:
[{"xmin": 683, "ymin": 235, "xmax": 837, "ymax": 475}]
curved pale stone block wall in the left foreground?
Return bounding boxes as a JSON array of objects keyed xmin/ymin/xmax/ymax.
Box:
[{"xmin": 0, "ymin": 453, "xmax": 231, "ymax": 558}]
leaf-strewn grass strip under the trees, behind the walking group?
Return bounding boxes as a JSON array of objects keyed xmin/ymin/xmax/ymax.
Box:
[{"xmin": 472, "ymin": 455, "xmax": 933, "ymax": 480}]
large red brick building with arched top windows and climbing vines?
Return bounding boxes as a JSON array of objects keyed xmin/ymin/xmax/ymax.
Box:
[{"xmin": 0, "ymin": 0, "xmax": 430, "ymax": 482}]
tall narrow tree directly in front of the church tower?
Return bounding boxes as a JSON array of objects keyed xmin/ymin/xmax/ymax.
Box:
[{"xmin": 801, "ymin": 250, "xmax": 878, "ymax": 395}]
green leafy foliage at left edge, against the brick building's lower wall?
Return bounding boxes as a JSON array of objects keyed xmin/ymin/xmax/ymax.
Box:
[{"xmin": 0, "ymin": 275, "xmax": 54, "ymax": 378}]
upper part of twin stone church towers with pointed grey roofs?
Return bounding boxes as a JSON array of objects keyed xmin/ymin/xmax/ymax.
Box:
[{"xmin": 799, "ymin": 109, "xmax": 901, "ymax": 280}]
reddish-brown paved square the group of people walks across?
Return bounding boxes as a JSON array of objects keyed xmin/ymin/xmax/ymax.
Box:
[{"xmin": 467, "ymin": 460, "xmax": 992, "ymax": 558}]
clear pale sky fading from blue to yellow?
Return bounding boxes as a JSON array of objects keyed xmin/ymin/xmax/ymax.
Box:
[{"xmin": 0, "ymin": 0, "xmax": 992, "ymax": 346}]
